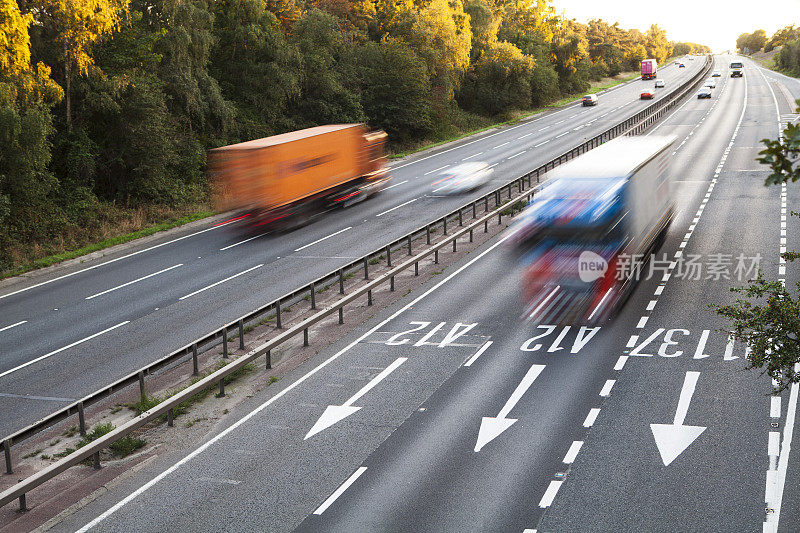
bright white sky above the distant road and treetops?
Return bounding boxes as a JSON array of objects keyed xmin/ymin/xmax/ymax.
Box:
[{"xmin": 553, "ymin": 0, "xmax": 800, "ymax": 52}]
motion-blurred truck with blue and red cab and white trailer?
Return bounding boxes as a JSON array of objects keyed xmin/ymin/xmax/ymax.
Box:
[{"xmin": 509, "ymin": 136, "xmax": 675, "ymax": 324}]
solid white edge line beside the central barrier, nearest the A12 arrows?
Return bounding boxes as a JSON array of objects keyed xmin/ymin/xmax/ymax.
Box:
[{"xmin": 76, "ymin": 234, "xmax": 511, "ymax": 533}]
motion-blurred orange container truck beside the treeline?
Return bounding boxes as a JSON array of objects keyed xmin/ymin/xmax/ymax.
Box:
[{"xmin": 209, "ymin": 124, "xmax": 389, "ymax": 229}]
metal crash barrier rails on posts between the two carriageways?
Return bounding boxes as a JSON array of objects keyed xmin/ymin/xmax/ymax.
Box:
[{"xmin": 0, "ymin": 56, "xmax": 711, "ymax": 510}]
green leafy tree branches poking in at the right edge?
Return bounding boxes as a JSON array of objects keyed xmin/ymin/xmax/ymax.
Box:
[{"xmin": 712, "ymin": 100, "xmax": 800, "ymax": 392}]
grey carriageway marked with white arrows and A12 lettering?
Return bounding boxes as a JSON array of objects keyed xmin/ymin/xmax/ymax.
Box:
[{"xmin": 39, "ymin": 56, "xmax": 800, "ymax": 532}]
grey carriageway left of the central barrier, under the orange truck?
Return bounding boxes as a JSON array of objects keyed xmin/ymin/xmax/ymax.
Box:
[{"xmin": 0, "ymin": 58, "xmax": 703, "ymax": 435}]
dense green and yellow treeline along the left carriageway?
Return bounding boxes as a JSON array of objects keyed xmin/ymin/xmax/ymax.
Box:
[{"xmin": 0, "ymin": 0, "xmax": 688, "ymax": 269}]
